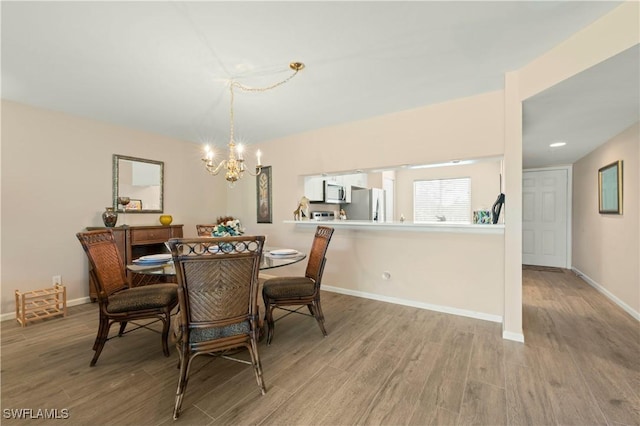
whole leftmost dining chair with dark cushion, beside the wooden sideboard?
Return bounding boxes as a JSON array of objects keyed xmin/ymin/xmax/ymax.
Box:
[{"xmin": 76, "ymin": 229, "xmax": 178, "ymax": 367}]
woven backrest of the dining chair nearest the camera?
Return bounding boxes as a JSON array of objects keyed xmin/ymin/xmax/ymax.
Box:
[{"xmin": 169, "ymin": 236, "xmax": 264, "ymax": 341}]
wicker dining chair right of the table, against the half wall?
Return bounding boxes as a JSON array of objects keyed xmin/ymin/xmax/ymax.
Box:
[{"xmin": 262, "ymin": 226, "xmax": 333, "ymax": 345}]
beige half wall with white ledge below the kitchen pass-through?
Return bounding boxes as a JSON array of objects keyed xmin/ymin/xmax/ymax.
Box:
[{"xmin": 282, "ymin": 220, "xmax": 505, "ymax": 322}]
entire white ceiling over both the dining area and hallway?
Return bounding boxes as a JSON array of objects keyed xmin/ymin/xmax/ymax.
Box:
[{"xmin": 1, "ymin": 1, "xmax": 639, "ymax": 167}]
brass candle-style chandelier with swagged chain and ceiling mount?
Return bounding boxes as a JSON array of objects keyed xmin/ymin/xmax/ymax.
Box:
[{"xmin": 202, "ymin": 62, "xmax": 304, "ymax": 187}]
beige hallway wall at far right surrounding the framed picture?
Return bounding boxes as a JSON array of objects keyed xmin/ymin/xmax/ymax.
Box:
[{"xmin": 572, "ymin": 123, "xmax": 640, "ymax": 318}]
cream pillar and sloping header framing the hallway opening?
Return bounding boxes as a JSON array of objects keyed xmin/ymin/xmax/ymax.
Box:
[{"xmin": 504, "ymin": 1, "xmax": 640, "ymax": 336}]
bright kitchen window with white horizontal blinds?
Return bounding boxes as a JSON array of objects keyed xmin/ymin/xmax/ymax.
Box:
[{"xmin": 413, "ymin": 178, "xmax": 471, "ymax": 223}]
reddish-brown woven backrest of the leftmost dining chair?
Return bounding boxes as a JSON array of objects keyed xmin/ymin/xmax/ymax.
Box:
[{"xmin": 76, "ymin": 229, "xmax": 129, "ymax": 302}]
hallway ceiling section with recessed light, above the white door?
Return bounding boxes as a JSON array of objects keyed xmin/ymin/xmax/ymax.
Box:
[{"xmin": 522, "ymin": 45, "xmax": 640, "ymax": 168}]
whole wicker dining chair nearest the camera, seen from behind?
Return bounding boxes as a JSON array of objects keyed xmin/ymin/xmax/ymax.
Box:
[{"xmin": 168, "ymin": 236, "xmax": 266, "ymax": 419}]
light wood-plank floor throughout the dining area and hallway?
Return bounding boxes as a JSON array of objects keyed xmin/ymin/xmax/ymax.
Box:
[{"xmin": 0, "ymin": 271, "xmax": 640, "ymax": 426}]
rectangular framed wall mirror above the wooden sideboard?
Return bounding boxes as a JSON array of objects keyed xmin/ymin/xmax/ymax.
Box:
[{"xmin": 113, "ymin": 154, "xmax": 164, "ymax": 213}]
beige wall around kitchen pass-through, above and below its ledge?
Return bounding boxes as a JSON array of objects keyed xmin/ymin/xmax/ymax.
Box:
[{"xmin": 228, "ymin": 92, "xmax": 504, "ymax": 318}]
